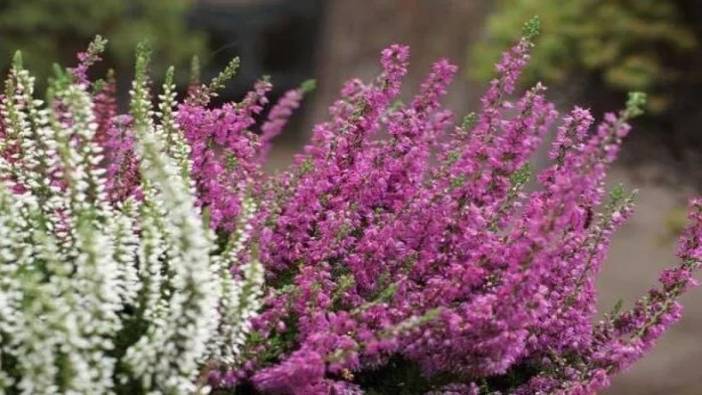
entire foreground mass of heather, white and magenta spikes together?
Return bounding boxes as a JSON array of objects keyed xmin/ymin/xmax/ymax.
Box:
[{"xmin": 0, "ymin": 17, "xmax": 702, "ymax": 394}]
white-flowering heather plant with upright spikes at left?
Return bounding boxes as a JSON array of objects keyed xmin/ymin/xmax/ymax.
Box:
[{"xmin": 0, "ymin": 38, "xmax": 263, "ymax": 394}]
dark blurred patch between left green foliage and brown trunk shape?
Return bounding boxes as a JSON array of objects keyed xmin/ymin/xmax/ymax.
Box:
[{"xmin": 188, "ymin": 0, "xmax": 324, "ymax": 99}]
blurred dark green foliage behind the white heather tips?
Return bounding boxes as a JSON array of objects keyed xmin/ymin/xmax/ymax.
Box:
[{"xmin": 0, "ymin": 0, "xmax": 206, "ymax": 81}]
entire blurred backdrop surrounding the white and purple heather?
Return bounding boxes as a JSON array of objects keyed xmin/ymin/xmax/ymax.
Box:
[{"xmin": 0, "ymin": 0, "xmax": 702, "ymax": 395}]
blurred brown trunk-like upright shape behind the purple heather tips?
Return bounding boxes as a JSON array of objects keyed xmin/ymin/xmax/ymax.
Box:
[{"xmin": 305, "ymin": 0, "xmax": 490, "ymax": 131}]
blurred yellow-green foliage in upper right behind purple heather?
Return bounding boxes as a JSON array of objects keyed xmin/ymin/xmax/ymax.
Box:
[{"xmin": 469, "ymin": 0, "xmax": 699, "ymax": 112}]
